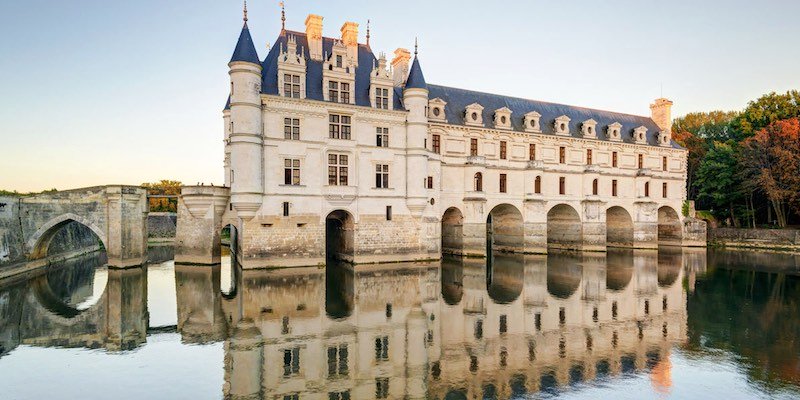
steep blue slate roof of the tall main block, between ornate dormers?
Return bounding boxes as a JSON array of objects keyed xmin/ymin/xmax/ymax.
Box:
[{"xmin": 261, "ymin": 31, "xmax": 403, "ymax": 110}]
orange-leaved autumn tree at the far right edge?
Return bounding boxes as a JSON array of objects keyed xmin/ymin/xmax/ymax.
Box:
[{"xmin": 741, "ymin": 117, "xmax": 800, "ymax": 227}]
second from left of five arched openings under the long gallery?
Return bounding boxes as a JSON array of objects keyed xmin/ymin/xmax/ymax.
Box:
[{"xmin": 486, "ymin": 203, "xmax": 525, "ymax": 254}]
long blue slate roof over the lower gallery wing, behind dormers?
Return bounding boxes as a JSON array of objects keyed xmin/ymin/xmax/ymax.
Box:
[{"xmin": 428, "ymin": 84, "xmax": 682, "ymax": 148}]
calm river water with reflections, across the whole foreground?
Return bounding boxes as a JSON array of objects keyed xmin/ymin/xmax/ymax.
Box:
[{"xmin": 0, "ymin": 247, "xmax": 800, "ymax": 400}]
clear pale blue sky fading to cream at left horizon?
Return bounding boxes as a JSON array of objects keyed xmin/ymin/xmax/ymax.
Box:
[{"xmin": 0, "ymin": 0, "xmax": 800, "ymax": 192}]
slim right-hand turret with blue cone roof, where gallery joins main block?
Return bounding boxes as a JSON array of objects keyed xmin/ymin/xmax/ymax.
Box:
[{"xmin": 403, "ymin": 45, "xmax": 428, "ymax": 215}]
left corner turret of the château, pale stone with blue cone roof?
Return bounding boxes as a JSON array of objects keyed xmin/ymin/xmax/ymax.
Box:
[{"xmin": 225, "ymin": 6, "xmax": 264, "ymax": 220}]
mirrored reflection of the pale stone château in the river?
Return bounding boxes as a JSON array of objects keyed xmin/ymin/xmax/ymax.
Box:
[{"xmin": 197, "ymin": 249, "xmax": 700, "ymax": 399}]
